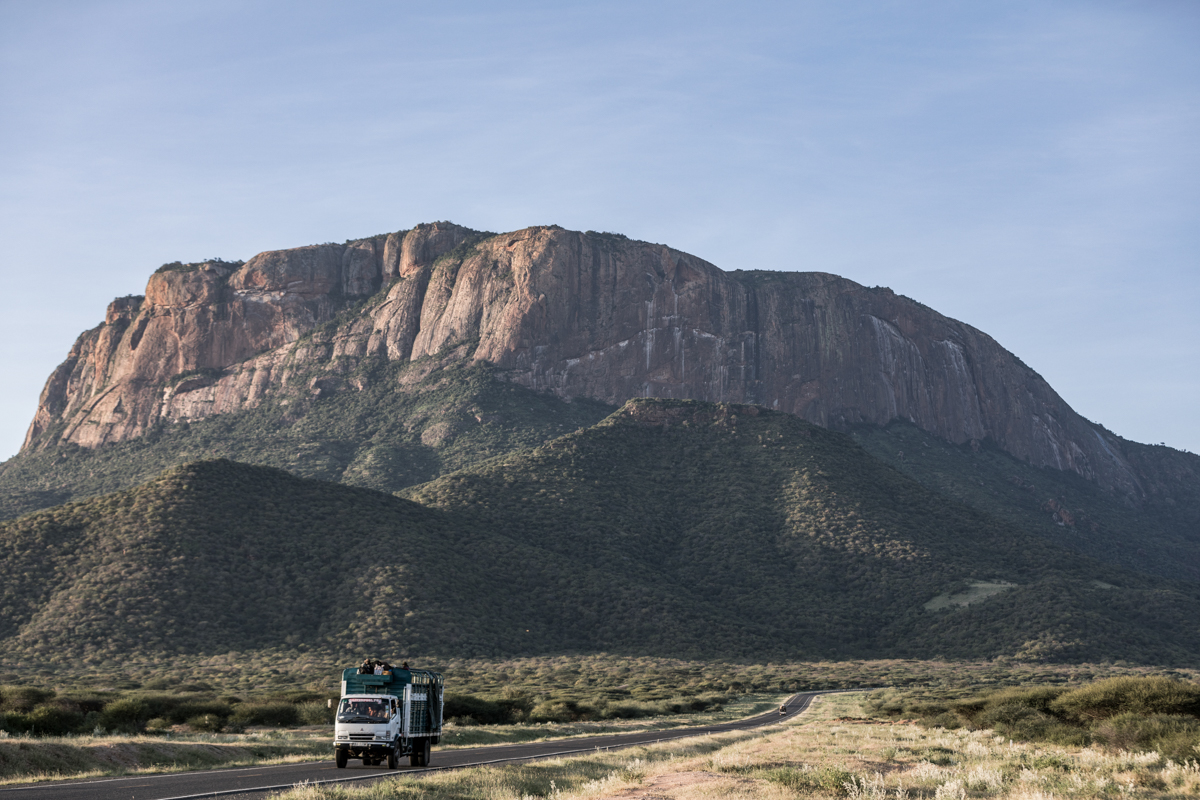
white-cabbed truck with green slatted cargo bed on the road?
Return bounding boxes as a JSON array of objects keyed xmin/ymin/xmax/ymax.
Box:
[{"xmin": 334, "ymin": 664, "xmax": 444, "ymax": 770}]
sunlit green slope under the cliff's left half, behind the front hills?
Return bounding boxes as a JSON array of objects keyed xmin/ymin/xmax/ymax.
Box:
[{"xmin": 0, "ymin": 362, "xmax": 613, "ymax": 519}]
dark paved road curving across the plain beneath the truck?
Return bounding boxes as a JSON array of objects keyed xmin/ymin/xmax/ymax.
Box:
[{"xmin": 0, "ymin": 692, "xmax": 823, "ymax": 800}]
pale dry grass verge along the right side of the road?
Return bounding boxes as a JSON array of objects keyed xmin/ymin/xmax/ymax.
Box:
[{"xmin": 272, "ymin": 694, "xmax": 1200, "ymax": 800}]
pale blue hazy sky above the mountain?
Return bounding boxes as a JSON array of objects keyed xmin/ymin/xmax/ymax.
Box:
[{"xmin": 0, "ymin": 0, "xmax": 1200, "ymax": 458}]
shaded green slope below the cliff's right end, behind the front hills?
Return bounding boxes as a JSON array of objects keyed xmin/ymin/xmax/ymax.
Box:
[{"xmin": 853, "ymin": 422, "xmax": 1200, "ymax": 582}]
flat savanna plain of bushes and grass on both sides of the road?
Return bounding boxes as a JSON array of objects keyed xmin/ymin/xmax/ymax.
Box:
[{"xmin": 0, "ymin": 657, "xmax": 1200, "ymax": 800}]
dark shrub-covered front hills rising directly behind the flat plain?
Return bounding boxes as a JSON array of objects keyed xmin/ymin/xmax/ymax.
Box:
[{"xmin": 0, "ymin": 401, "xmax": 1200, "ymax": 663}]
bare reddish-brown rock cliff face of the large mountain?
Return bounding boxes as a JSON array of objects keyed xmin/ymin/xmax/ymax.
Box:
[{"xmin": 25, "ymin": 223, "xmax": 1144, "ymax": 498}]
